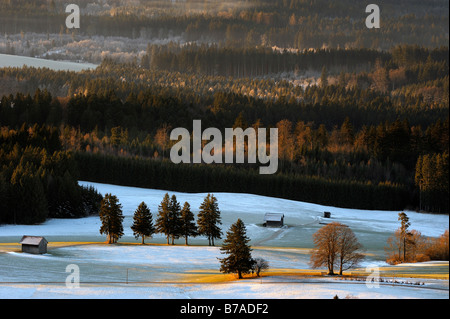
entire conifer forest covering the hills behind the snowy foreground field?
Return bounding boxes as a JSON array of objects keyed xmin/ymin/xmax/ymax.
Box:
[{"xmin": 0, "ymin": 0, "xmax": 449, "ymax": 224}]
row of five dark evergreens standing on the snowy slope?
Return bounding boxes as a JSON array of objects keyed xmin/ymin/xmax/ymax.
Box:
[{"xmin": 99, "ymin": 193, "xmax": 222, "ymax": 246}]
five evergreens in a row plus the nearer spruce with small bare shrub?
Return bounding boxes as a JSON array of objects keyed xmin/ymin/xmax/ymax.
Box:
[{"xmin": 100, "ymin": 193, "xmax": 258, "ymax": 278}]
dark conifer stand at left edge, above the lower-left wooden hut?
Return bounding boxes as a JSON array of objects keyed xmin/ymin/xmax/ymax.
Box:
[{"xmin": 0, "ymin": 125, "xmax": 102, "ymax": 224}]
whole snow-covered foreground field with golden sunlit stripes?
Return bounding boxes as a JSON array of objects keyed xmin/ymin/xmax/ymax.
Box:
[{"xmin": 0, "ymin": 182, "xmax": 449, "ymax": 299}]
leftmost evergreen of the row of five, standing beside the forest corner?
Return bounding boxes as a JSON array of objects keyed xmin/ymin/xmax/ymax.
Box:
[{"xmin": 99, "ymin": 194, "xmax": 123, "ymax": 244}]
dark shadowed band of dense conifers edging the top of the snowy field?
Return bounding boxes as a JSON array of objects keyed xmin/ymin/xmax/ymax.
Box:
[{"xmin": 75, "ymin": 152, "xmax": 414, "ymax": 210}]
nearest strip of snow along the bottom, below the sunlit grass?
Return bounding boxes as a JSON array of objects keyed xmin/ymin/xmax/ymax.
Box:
[{"xmin": 0, "ymin": 278, "xmax": 449, "ymax": 300}]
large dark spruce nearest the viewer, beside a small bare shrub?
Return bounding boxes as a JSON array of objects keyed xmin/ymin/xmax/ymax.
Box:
[{"xmin": 219, "ymin": 219, "xmax": 254, "ymax": 279}]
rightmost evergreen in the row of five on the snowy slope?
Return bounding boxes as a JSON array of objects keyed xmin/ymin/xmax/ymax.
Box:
[{"xmin": 197, "ymin": 194, "xmax": 222, "ymax": 246}]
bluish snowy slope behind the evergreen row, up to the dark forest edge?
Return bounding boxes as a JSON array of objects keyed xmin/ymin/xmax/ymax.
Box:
[{"xmin": 0, "ymin": 181, "xmax": 449, "ymax": 250}]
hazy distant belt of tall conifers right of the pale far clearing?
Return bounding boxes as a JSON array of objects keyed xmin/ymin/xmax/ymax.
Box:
[{"xmin": 145, "ymin": 44, "xmax": 390, "ymax": 78}]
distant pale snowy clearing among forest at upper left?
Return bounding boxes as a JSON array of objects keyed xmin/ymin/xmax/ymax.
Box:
[{"xmin": 0, "ymin": 54, "xmax": 97, "ymax": 72}]
